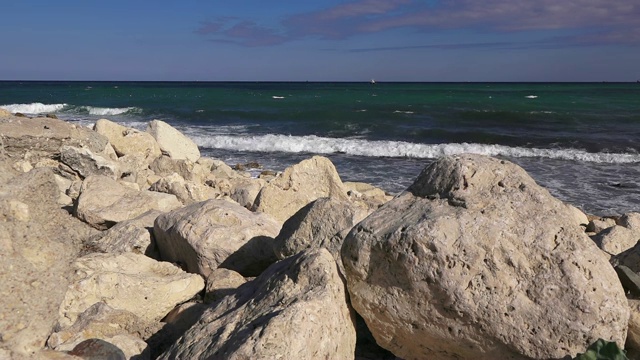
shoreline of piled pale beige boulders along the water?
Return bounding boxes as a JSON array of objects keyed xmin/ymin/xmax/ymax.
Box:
[{"xmin": 0, "ymin": 110, "xmax": 640, "ymax": 359}]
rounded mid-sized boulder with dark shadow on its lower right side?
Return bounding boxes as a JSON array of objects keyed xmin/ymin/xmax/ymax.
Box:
[{"xmin": 153, "ymin": 200, "xmax": 280, "ymax": 277}]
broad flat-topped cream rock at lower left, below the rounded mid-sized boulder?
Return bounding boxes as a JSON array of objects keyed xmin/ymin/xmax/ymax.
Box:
[{"xmin": 59, "ymin": 253, "xmax": 204, "ymax": 327}]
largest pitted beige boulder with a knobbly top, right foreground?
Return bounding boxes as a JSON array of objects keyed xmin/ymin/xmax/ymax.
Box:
[{"xmin": 342, "ymin": 155, "xmax": 629, "ymax": 359}]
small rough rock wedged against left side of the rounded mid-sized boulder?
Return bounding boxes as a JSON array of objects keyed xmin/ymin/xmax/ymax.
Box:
[{"xmin": 87, "ymin": 210, "xmax": 163, "ymax": 259}]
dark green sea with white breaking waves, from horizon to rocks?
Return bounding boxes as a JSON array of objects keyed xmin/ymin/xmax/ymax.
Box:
[{"xmin": 0, "ymin": 81, "xmax": 640, "ymax": 216}]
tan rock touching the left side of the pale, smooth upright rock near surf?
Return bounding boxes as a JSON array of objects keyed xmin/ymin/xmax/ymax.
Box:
[{"xmin": 93, "ymin": 119, "xmax": 162, "ymax": 165}]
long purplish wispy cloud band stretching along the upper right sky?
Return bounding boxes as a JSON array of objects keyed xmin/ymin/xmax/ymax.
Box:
[{"xmin": 196, "ymin": 0, "xmax": 640, "ymax": 46}]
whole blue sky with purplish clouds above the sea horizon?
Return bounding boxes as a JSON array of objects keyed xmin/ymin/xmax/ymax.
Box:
[{"xmin": 0, "ymin": 0, "xmax": 640, "ymax": 81}]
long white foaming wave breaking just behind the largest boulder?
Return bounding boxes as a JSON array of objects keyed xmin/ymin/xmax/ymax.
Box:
[{"xmin": 192, "ymin": 134, "xmax": 640, "ymax": 164}]
